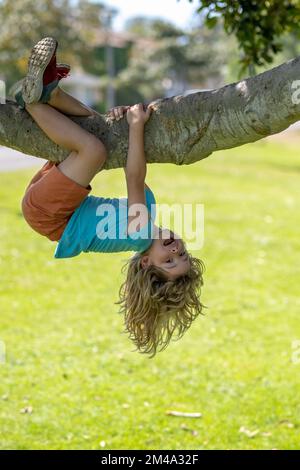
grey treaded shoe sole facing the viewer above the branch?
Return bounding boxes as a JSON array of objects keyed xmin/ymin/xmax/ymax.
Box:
[{"xmin": 22, "ymin": 37, "xmax": 57, "ymax": 104}]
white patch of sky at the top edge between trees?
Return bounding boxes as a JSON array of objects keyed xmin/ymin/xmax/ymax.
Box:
[{"xmin": 101, "ymin": 0, "xmax": 199, "ymax": 31}]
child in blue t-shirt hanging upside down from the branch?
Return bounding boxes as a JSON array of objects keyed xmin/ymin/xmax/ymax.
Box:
[{"xmin": 14, "ymin": 37, "xmax": 204, "ymax": 357}]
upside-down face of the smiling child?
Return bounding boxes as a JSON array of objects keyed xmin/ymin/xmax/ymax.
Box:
[{"xmin": 142, "ymin": 226, "xmax": 190, "ymax": 280}]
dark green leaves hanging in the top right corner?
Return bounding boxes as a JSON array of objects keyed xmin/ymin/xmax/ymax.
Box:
[{"xmin": 189, "ymin": 0, "xmax": 300, "ymax": 76}]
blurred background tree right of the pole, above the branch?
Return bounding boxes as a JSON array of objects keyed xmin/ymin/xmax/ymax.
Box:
[{"xmin": 116, "ymin": 17, "xmax": 232, "ymax": 103}]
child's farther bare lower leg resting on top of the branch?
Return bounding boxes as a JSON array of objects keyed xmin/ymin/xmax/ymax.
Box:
[{"xmin": 48, "ymin": 86, "xmax": 99, "ymax": 116}]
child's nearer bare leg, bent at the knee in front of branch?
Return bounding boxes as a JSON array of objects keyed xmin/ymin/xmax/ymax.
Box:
[{"xmin": 26, "ymin": 103, "xmax": 106, "ymax": 187}]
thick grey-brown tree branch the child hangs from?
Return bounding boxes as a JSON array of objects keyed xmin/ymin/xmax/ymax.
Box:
[{"xmin": 0, "ymin": 56, "xmax": 300, "ymax": 170}]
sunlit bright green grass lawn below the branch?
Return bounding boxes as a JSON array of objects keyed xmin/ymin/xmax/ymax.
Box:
[{"xmin": 0, "ymin": 141, "xmax": 300, "ymax": 449}]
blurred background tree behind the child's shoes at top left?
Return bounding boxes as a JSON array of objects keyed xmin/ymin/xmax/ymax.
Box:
[{"xmin": 0, "ymin": 0, "xmax": 104, "ymax": 89}]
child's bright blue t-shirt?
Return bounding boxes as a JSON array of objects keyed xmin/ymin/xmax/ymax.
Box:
[{"xmin": 54, "ymin": 188, "xmax": 156, "ymax": 258}]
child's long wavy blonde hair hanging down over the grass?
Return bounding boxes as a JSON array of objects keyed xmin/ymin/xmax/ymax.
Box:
[{"xmin": 115, "ymin": 250, "xmax": 206, "ymax": 358}]
